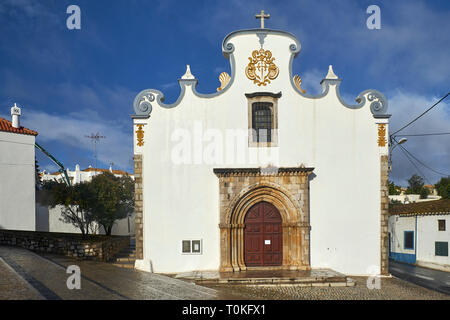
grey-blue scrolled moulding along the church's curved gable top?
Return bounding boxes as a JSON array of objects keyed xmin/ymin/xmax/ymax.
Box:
[{"xmin": 132, "ymin": 29, "xmax": 390, "ymax": 118}]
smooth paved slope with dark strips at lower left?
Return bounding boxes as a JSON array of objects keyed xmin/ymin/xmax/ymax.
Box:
[{"xmin": 0, "ymin": 246, "xmax": 220, "ymax": 300}]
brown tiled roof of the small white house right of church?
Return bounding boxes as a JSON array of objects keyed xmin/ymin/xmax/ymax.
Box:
[{"xmin": 389, "ymin": 199, "xmax": 450, "ymax": 215}]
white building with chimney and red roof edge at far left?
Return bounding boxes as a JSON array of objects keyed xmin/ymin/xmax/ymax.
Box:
[{"xmin": 0, "ymin": 104, "xmax": 38, "ymax": 231}]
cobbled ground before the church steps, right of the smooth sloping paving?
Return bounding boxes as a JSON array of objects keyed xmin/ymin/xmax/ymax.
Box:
[{"xmin": 205, "ymin": 277, "xmax": 450, "ymax": 300}]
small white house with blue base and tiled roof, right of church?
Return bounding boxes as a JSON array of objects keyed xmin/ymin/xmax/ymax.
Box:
[{"xmin": 389, "ymin": 199, "xmax": 450, "ymax": 271}]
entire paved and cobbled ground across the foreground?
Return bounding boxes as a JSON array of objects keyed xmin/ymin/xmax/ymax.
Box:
[{"xmin": 0, "ymin": 246, "xmax": 450, "ymax": 300}]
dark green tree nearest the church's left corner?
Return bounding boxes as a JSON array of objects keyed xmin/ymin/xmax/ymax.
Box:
[{"xmin": 91, "ymin": 172, "xmax": 134, "ymax": 235}]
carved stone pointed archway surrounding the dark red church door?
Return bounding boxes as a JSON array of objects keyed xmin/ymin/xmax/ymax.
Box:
[{"xmin": 214, "ymin": 168, "xmax": 313, "ymax": 272}]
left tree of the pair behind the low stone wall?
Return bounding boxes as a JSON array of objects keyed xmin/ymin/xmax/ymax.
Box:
[{"xmin": 39, "ymin": 181, "xmax": 97, "ymax": 237}]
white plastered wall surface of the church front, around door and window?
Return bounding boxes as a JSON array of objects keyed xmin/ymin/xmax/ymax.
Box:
[{"xmin": 133, "ymin": 30, "xmax": 387, "ymax": 274}]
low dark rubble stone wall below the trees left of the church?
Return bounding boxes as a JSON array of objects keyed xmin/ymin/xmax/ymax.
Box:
[{"xmin": 0, "ymin": 230, "xmax": 130, "ymax": 261}]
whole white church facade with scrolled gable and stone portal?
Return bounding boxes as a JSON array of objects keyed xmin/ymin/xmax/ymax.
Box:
[{"xmin": 132, "ymin": 19, "xmax": 389, "ymax": 275}]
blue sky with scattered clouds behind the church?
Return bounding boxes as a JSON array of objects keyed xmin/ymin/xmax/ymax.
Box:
[{"xmin": 0, "ymin": 0, "xmax": 450, "ymax": 185}]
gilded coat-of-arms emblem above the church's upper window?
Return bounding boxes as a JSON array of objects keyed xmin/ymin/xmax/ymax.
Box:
[{"xmin": 245, "ymin": 48, "xmax": 279, "ymax": 86}]
